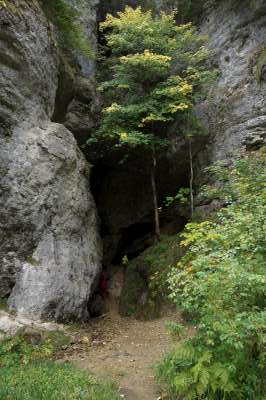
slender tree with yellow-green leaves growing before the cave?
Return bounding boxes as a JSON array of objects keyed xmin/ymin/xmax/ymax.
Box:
[{"xmin": 91, "ymin": 7, "xmax": 214, "ymax": 237}]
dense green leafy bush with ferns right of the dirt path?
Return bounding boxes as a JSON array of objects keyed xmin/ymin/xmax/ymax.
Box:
[{"xmin": 159, "ymin": 150, "xmax": 266, "ymax": 400}]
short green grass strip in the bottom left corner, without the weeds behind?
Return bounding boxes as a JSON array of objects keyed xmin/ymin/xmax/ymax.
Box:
[{"xmin": 0, "ymin": 361, "xmax": 120, "ymax": 400}]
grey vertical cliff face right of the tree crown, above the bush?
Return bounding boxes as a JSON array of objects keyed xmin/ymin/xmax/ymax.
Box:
[{"xmin": 197, "ymin": 0, "xmax": 266, "ymax": 162}]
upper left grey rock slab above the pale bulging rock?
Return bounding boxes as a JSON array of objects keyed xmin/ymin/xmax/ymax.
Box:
[{"xmin": 0, "ymin": 0, "xmax": 58, "ymax": 134}]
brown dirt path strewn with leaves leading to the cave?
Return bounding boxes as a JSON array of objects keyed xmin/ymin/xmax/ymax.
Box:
[{"xmin": 63, "ymin": 311, "xmax": 185, "ymax": 400}]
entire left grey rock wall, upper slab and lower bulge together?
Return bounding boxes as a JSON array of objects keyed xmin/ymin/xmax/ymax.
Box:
[{"xmin": 0, "ymin": 0, "xmax": 101, "ymax": 319}]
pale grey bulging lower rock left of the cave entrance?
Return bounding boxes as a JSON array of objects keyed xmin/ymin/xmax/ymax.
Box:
[{"xmin": 5, "ymin": 123, "xmax": 100, "ymax": 319}]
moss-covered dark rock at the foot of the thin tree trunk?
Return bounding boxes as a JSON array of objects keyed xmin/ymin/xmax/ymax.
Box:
[{"xmin": 120, "ymin": 235, "xmax": 184, "ymax": 319}]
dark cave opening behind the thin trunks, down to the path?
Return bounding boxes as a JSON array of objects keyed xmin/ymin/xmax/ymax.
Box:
[{"xmin": 88, "ymin": 157, "xmax": 189, "ymax": 318}]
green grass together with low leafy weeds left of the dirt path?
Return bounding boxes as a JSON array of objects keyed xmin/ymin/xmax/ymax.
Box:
[{"xmin": 0, "ymin": 331, "xmax": 120, "ymax": 400}]
